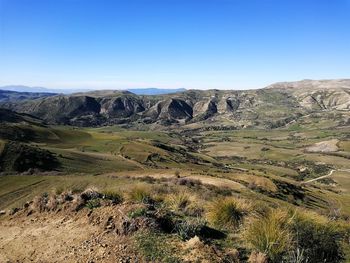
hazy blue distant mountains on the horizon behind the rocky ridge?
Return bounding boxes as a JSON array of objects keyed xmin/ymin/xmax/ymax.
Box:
[{"xmin": 0, "ymin": 85, "xmax": 186, "ymax": 95}]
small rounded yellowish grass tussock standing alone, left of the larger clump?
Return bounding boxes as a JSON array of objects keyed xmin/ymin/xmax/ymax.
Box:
[{"xmin": 207, "ymin": 198, "xmax": 251, "ymax": 228}]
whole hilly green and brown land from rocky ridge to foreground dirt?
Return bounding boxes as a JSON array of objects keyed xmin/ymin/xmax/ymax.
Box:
[{"xmin": 0, "ymin": 80, "xmax": 350, "ymax": 263}]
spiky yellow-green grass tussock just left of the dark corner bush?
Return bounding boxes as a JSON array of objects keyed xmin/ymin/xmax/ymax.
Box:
[{"xmin": 244, "ymin": 210, "xmax": 292, "ymax": 262}]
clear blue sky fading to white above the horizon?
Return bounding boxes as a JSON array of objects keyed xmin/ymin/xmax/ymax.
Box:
[{"xmin": 0, "ymin": 0, "xmax": 350, "ymax": 89}]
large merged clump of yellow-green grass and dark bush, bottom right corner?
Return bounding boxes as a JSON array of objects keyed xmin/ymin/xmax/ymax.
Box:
[{"xmin": 244, "ymin": 209, "xmax": 349, "ymax": 263}]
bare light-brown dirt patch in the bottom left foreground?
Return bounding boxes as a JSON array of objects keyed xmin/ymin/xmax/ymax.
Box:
[{"xmin": 0, "ymin": 206, "xmax": 144, "ymax": 262}]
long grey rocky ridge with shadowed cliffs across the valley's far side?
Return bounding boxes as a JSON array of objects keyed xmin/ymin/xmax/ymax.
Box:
[{"xmin": 0, "ymin": 80, "xmax": 350, "ymax": 127}]
